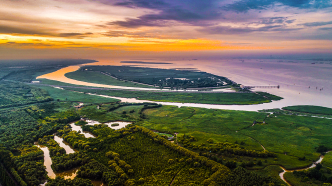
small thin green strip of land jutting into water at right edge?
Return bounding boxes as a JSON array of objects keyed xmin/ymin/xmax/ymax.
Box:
[{"xmin": 282, "ymin": 105, "xmax": 332, "ymax": 115}]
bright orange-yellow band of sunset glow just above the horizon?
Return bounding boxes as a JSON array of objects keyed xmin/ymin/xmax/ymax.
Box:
[{"xmin": 0, "ymin": 35, "xmax": 283, "ymax": 52}]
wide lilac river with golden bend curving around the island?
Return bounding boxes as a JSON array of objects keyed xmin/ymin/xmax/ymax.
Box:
[{"xmin": 38, "ymin": 59, "xmax": 332, "ymax": 111}]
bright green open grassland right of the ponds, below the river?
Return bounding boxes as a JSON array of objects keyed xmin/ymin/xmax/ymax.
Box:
[{"xmin": 140, "ymin": 106, "xmax": 332, "ymax": 169}]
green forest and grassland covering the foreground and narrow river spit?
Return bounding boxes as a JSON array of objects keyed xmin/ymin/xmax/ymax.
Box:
[{"xmin": 0, "ymin": 64, "xmax": 332, "ymax": 186}]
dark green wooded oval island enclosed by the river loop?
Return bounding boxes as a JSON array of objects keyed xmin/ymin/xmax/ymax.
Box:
[{"xmin": 72, "ymin": 66, "xmax": 233, "ymax": 89}]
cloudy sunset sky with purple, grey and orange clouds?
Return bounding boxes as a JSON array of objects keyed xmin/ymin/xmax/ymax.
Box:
[{"xmin": 0, "ymin": 0, "xmax": 332, "ymax": 59}]
